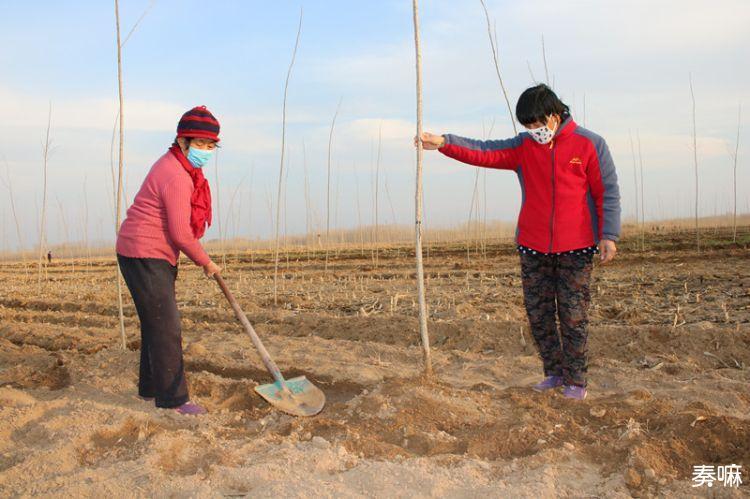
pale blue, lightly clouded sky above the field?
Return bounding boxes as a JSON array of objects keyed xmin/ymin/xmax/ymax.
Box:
[{"xmin": 0, "ymin": 0, "xmax": 750, "ymax": 248}]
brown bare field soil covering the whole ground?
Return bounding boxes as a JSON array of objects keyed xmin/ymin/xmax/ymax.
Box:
[{"xmin": 0, "ymin": 239, "xmax": 750, "ymax": 497}]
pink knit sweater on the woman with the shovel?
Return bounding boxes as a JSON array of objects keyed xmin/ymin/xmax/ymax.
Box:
[{"xmin": 117, "ymin": 152, "xmax": 211, "ymax": 266}]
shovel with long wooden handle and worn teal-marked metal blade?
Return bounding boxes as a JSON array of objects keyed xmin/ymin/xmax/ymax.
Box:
[{"xmin": 214, "ymin": 274, "xmax": 326, "ymax": 416}]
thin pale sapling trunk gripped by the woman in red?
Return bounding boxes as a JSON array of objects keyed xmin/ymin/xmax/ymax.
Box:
[{"xmin": 412, "ymin": 0, "xmax": 432, "ymax": 376}]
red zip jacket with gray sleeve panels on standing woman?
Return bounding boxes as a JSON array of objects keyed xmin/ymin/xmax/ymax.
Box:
[{"xmin": 440, "ymin": 118, "xmax": 620, "ymax": 253}]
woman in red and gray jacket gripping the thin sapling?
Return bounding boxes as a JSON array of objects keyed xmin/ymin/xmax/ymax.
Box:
[{"xmin": 422, "ymin": 84, "xmax": 620, "ymax": 400}]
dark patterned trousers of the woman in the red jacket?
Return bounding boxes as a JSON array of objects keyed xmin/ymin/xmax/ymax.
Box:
[{"xmin": 521, "ymin": 254, "xmax": 593, "ymax": 386}]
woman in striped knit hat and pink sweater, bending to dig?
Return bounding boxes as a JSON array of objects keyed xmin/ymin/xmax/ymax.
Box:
[{"xmin": 117, "ymin": 106, "xmax": 221, "ymax": 415}]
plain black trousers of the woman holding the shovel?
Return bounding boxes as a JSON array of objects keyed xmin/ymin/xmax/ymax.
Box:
[{"xmin": 117, "ymin": 255, "xmax": 188, "ymax": 407}]
